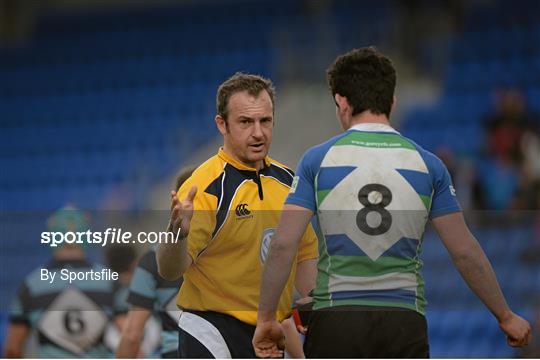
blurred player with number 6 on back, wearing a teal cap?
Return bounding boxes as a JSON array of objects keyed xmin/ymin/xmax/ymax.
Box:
[{"xmin": 5, "ymin": 206, "xmax": 119, "ymax": 358}]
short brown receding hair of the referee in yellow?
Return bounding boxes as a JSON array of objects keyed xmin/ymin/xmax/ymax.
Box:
[{"xmin": 216, "ymin": 72, "xmax": 275, "ymax": 121}]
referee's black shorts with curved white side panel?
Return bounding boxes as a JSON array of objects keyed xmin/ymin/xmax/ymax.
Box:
[{"xmin": 178, "ymin": 310, "xmax": 255, "ymax": 359}]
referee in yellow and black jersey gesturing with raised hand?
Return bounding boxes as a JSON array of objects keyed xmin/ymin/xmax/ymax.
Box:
[{"xmin": 157, "ymin": 73, "xmax": 317, "ymax": 358}]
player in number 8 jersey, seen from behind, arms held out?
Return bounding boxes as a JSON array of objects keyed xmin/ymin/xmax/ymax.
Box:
[{"xmin": 253, "ymin": 48, "xmax": 531, "ymax": 358}]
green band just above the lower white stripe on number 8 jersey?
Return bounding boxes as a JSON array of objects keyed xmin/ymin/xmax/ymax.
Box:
[{"xmin": 331, "ymin": 255, "xmax": 418, "ymax": 276}]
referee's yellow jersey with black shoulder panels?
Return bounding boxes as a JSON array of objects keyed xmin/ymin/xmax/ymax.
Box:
[{"xmin": 178, "ymin": 149, "xmax": 318, "ymax": 325}]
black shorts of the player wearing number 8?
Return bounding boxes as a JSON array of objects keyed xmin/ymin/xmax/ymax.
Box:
[{"xmin": 304, "ymin": 306, "xmax": 429, "ymax": 358}]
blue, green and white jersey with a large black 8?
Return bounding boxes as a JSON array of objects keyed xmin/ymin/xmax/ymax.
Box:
[{"xmin": 286, "ymin": 124, "xmax": 461, "ymax": 314}]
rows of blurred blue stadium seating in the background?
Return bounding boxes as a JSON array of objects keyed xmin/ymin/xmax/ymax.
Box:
[{"xmin": 0, "ymin": 1, "xmax": 540, "ymax": 358}]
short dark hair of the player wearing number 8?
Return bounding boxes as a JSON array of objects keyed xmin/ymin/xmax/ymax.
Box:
[{"xmin": 326, "ymin": 47, "xmax": 396, "ymax": 118}]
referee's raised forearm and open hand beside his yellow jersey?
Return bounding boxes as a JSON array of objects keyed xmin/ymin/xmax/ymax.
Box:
[{"xmin": 156, "ymin": 186, "xmax": 197, "ymax": 281}]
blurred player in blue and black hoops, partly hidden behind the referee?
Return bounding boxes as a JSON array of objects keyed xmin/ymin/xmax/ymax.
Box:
[{"xmin": 116, "ymin": 167, "xmax": 195, "ymax": 358}]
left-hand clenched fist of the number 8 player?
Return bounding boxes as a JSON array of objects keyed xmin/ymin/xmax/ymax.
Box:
[{"xmin": 252, "ymin": 320, "xmax": 285, "ymax": 358}]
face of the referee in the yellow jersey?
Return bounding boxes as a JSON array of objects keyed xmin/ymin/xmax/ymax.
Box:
[{"xmin": 216, "ymin": 91, "xmax": 274, "ymax": 169}]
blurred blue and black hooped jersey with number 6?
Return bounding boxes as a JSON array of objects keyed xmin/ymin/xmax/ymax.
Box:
[{"xmin": 10, "ymin": 260, "xmax": 116, "ymax": 358}]
